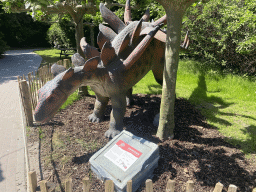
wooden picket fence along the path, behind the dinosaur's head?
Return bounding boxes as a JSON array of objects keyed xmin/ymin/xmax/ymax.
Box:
[{"xmin": 18, "ymin": 59, "xmax": 71, "ymax": 126}]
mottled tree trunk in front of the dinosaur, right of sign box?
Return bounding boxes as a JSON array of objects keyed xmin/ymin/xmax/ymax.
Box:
[{"xmin": 157, "ymin": 4, "xmax": 184, "ymax": 139}]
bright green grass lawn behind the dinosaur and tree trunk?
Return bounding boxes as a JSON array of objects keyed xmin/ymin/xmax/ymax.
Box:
[{"xmin": 36, "ymin": 50, "xmax": 256, "ymax": 158}]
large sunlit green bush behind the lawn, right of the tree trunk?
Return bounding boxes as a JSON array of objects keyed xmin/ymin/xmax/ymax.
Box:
[{"xmin": 183, "ymin": 0, "xmax": 256, "ymax": 75}]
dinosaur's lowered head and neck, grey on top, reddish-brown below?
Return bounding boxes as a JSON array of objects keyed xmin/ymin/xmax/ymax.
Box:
[{"xmin": 34, "ymin": 57, "xmax": 99, "ymax": 123}]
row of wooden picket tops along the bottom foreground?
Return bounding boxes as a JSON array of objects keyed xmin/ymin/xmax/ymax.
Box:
[{"xmin": 28, "ymin": 171, "xmax": 256, "ymax": 192}]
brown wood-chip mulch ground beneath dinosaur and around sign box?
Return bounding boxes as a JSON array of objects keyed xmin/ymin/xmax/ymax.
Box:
[{"xmin": 28, "ymin": 94, "xmax": 256, "ymax": 192}]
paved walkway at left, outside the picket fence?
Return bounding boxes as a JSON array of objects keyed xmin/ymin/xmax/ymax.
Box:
[{"xmin": 0, "ymin": 50, "xmax": 42, "ymax": 192}]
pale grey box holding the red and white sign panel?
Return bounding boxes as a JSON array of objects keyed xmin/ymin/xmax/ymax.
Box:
[{"xmin": 89, "ymin": 130, "xmax": 159, "ymax": 192}]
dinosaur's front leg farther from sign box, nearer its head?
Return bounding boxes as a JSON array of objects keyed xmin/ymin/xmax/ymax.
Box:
[{"xmin": 88, "ymin": 93, "xmax": 109, "ymax": 123}]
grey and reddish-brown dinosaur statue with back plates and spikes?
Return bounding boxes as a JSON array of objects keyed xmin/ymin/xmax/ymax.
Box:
[{"xmin": 35, "ymin": 0, "xmax": 188, "ymax": 138}]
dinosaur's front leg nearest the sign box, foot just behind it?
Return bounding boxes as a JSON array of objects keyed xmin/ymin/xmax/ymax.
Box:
[{"xmin": 105, "ymin": 95, "xmax": 126, "ymax": 138}]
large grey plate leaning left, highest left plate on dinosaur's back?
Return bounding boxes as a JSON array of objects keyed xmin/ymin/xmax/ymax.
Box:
[{"xmin": 100, "ymin": 3, "xmax": 125, "ymax": 33}]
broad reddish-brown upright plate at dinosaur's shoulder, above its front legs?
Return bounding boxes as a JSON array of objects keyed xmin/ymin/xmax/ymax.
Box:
[{"xmin": 100, "ymin": 41, "xmax": 117, "ymax": 66}]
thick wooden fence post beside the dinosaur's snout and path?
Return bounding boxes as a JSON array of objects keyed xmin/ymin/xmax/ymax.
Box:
[{"xmin": 20, "ymin": 80, "xmax": 33, "ymax": 127}]
